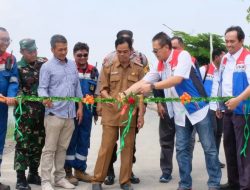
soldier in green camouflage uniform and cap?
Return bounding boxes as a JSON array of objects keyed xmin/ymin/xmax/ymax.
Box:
[{"xmin": 14, "ymin": 39, "xmax": 47, "ymax": 190}]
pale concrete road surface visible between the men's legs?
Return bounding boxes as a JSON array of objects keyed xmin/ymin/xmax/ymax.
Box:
[{"xmin": 0, "ymin": 106, "xmax": 226, "ymax": 190}]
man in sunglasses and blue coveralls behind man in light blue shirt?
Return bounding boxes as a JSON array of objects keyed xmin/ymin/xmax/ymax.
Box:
[{"xmin": 64, "ymin": 42, "xmax": 99, "ymax": 185}]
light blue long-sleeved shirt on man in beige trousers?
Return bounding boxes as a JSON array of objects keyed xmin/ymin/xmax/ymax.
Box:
[{"xmin": 38, "ymin": 57, "xmax": 82, "ymax": 118}]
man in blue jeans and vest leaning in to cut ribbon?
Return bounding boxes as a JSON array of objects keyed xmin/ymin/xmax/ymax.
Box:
[{"xmin": 123, "ymin": 32, "xmax": 221, "ymax": 190}]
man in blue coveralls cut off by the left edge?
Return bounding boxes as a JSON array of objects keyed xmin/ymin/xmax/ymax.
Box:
[{"xmin": 0, "ymin": 27, "xmax": 18, "ymax": 190}]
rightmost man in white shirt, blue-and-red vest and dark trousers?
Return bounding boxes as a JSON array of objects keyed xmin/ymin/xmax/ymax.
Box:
[{"xmin": 220, "ymin": 26, "xmax": 250, "ymax": 190}]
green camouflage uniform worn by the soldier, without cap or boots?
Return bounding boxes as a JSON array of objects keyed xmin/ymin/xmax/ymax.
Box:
[{"xmin": 14, "ymin": 58, "xmax": 47, "ymax": 172}]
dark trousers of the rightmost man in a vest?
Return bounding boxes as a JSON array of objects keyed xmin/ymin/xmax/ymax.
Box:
[{"xmin": 223, "ymin": 111, "xmax": 250, "ymax": 190}]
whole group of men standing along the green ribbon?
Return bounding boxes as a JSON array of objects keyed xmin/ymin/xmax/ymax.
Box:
[{"xmin": 0, "ymin": 26, "xmax": 250, "ymax": 190}]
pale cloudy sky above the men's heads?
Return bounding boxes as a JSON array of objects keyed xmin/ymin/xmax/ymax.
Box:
[{"xmin": 0, "ymin": 0, "xmax": 250, "ymax": 66}]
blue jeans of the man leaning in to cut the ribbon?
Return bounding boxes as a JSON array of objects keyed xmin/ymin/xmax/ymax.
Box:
[{"xmin": 175, "ymin": 113, "xmax": 221, "ymax": 188}]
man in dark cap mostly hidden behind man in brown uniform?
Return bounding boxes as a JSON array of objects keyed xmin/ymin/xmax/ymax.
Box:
[{"xmin": 99, "ymin": 30, "xmax": 149, "ymax": 185}]
